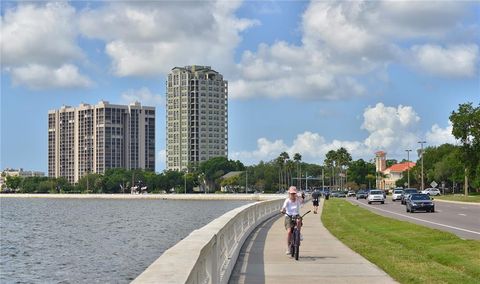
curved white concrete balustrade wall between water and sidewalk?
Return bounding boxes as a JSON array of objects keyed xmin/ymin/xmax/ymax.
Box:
[{"xmin": 132, "ymin": 197, "xmax": 285, "ymax": 284}]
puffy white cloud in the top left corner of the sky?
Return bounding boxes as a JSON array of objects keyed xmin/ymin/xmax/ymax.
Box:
[{"xmin": 0, "ymin": 3, "xmax": 82, "ymax": 66}]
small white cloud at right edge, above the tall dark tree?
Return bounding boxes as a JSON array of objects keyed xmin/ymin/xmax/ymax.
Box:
[{"xmin": 411, "ymin": 44, "xmax": 479, "ymax": 77}]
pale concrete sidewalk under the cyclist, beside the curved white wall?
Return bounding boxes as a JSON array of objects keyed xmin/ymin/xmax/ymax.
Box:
[{"xmin": 229, "ymin": 199, "xmax": 396, "ymax": 284}]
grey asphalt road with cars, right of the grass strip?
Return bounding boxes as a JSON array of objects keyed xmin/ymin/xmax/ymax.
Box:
[{"xmin": 347, "ymin": 195, "xmax": 480, "ymax": 240}]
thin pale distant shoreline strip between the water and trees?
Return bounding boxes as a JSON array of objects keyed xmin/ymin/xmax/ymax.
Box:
[{"xmin": 0, "ymin": 193, "xmax": 285, "ymax": 201}]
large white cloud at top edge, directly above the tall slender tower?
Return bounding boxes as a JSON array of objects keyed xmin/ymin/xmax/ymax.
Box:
[{"xmin": 80, "ymin": 1, "xmax": 257, "ymax": 76}]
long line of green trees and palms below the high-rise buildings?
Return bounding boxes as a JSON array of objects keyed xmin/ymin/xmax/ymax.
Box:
[{"xmin": 6, "ymin": 103, "xmax": 480, "ymax": 193}]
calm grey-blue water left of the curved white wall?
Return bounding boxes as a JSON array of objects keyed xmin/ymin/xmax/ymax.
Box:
[{"xmin": 0, "ymin": 198, "xmax": 248, "ymax": 283}]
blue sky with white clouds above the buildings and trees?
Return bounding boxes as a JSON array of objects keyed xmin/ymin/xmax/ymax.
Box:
[{"xmin": 0, "ymin": 0, "xmax": 480, "ymax": 172}]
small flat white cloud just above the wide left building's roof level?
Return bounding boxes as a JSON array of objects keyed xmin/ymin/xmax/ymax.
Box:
[{"xmin": 11, "ymin": 64, "xmax": 93, "ymax": 90}]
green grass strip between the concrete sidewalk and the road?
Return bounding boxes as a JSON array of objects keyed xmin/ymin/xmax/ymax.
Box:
[{"xmin": 322, "ymin": 199, "xmax": 480, "ymax": 284}]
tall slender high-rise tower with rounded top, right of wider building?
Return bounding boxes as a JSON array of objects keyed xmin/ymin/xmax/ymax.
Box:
[{"xmin": 166, "ymin": 65, "xmax": 228, "ymax": 171}]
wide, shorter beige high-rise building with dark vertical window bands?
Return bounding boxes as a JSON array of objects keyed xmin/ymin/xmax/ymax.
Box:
[{"xmin": 48, "ymin": 101, "xmax": 155, "ymax": 183}]
